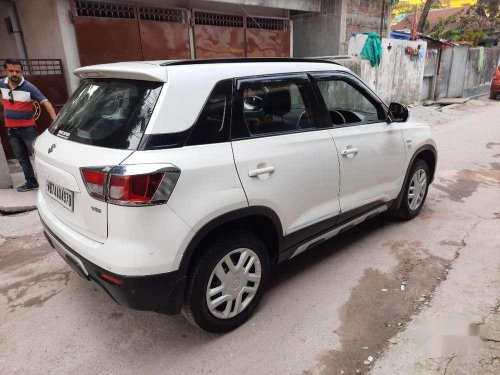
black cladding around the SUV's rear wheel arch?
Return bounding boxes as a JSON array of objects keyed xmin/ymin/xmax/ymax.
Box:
[{"xmin": 179, "ymin": 207, "xmax": 283, "ymax": 280}]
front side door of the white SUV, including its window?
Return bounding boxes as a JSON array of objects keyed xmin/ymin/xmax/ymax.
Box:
[{"xmin": 313, "ymin": 73, "xmax": 405, "ymax": 220}]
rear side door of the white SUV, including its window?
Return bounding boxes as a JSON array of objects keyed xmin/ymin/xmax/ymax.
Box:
[{"xmin": 231, "ymin": 74, "xmax": 340, "ymax": 235}]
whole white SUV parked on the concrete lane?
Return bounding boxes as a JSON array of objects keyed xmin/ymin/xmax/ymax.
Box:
[{"xmin": 35, "ymin": 59, "xmax": 437, "ymax": 332}]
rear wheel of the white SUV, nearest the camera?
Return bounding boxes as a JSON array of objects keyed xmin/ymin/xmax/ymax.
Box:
[{"xmin": 183, "ymin": 230, "xmax": 270, "ymax": 333}]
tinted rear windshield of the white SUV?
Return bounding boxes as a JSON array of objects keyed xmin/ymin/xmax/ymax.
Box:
[{"xmin": 50, "ymin": 79, "xmax": 163, "ymax": 150}]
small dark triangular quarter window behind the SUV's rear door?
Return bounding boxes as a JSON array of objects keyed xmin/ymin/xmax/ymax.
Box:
[{"xmin": 187, "ymin": 80, "xmax": 233, "ymax": 146}]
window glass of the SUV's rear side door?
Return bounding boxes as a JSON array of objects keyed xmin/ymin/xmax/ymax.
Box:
[{"xmin": 243, "ymin": 82, "xmax": 315, "ymax": 135}]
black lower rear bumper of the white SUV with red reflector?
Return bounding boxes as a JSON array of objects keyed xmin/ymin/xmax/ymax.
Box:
[{"xmin": 42, "ymin": 220, "xmax": 186, "ymax": 315}]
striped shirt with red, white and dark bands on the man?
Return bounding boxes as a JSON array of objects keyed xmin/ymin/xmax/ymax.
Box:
[{"xmin": 0, "ymin": 78, "xmax": 47, "ymax": 128}]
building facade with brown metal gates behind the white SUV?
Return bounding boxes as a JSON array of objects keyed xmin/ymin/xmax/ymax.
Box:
[{"xmin": 0, "ymin": 0, "xmax": 390, "ymax": 93}]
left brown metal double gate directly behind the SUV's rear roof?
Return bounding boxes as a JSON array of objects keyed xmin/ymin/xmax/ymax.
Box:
[{"xmin": 73, "ymin": 1, "xmax": 191, "ymax": 66}]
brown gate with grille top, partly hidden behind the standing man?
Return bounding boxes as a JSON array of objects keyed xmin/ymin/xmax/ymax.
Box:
[{"xmin": 0, "ymin": 58, "xmax": 68, "ymax": 159}]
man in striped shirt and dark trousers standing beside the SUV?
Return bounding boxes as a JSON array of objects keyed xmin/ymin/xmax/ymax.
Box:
[{"xmin": 0, "ymin": 59, "xmax": 56, "ymax": 192}]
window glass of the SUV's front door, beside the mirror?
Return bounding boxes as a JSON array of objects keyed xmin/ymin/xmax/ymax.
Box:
[{"xmin": 317, "ymin": 79, "xmax": 385, "ymax": 126}]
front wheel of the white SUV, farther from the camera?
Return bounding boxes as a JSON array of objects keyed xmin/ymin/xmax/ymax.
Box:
[{"xmin": 392, "ymin": 159, "xmax": 430, "ymax": 220}]
